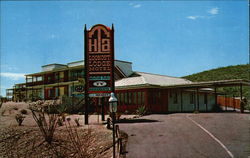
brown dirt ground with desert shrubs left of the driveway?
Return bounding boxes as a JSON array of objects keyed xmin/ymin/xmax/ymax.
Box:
[{"xmin": 0, "ymin": 102, "xmax": 115, "ymax": 158}]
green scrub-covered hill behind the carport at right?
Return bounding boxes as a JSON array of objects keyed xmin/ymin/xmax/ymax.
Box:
[{"xmin": 182, "ymin": 64, "xmax": 250, "ymax": 99}]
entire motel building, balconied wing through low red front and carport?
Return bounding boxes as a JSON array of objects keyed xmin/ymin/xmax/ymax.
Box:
[{"xmin": 6, "ymin": 60, "xmax": 250, "ymax": 113}]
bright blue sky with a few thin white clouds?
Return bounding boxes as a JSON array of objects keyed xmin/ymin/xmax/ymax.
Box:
[{"xmin": 0, "ymin": 0, "xmax": 249, "ymax": 96}]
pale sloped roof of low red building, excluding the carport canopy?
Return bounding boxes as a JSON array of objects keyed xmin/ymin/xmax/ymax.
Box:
[{"xmin": 115, "ymin": 72, "xmax": 192, "ymax": 88}]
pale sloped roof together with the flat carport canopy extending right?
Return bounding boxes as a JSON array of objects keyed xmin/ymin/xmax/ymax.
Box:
[{"xmin": 115, "ymin": 72, "xmax": 250, "ymax": 91}]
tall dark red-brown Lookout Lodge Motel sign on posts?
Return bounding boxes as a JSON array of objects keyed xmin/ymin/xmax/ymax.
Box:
[{"xmin": 84, "ymin": 24, "xmax": 114, "ymax": 124}]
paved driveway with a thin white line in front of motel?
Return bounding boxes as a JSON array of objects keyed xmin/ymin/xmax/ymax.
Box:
[{"xmin": 119, "ymin": 113, "xmax": 250, "ymax": 158}]
